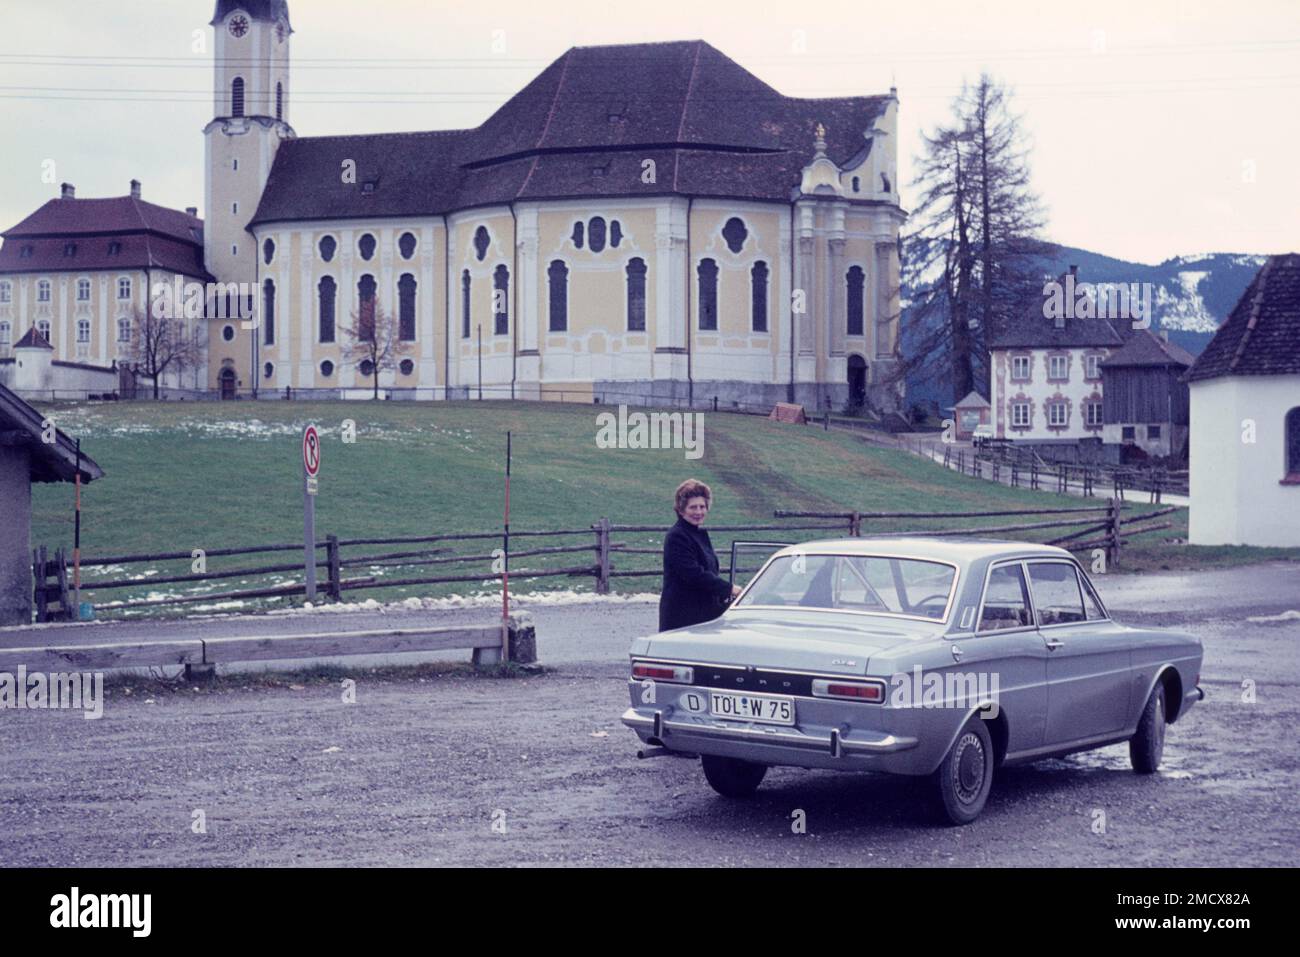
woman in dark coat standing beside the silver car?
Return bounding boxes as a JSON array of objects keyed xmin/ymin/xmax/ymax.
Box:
[{"xmin": 659, "ymin": 479, "xmax": 740, "ymax": 632}]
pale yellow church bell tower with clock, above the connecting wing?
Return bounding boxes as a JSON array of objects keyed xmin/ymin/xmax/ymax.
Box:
[{"xmin": 203, "ymin": 0, "xmax": 294, "ymax": 289}]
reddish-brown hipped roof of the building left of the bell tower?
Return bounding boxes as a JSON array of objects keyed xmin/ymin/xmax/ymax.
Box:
[{"xmin": 0, "ymin": 195, "xmax": 212, "ymax": 281}]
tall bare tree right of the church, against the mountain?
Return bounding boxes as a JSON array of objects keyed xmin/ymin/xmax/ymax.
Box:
[{"xmin": 901, "ymin": 74, "xmax": 1050, "ymax": 399}]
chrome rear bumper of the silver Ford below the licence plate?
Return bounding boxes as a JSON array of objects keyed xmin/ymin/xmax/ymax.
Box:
[{"xmin": 623, "ymin": 707, "xmax": 924, "ymax": 774}]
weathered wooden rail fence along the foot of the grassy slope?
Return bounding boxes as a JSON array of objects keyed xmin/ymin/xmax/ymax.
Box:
[{"xmin": 33, "ymin": 498, "xmax": 1175, "ymax": 622}]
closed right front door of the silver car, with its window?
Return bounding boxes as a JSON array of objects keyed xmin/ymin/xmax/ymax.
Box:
[{"xmin": 1026, "ymin": 559, "xmax": 1132, "ymax": 745}]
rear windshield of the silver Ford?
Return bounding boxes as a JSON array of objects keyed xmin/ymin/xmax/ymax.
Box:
[{"xmin": 737, "ymin": 555, "xmax": 957, "ymax": 622}]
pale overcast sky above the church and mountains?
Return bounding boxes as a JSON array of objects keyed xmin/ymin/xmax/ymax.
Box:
[{"xmin": 0, "ymin": 0, "xmax": 1300, "ymax": 263}]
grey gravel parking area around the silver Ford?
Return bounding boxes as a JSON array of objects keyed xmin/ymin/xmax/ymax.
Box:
[{"xmin": 0, "ymin": 564, "xmax": 1300, "ymax": 866}]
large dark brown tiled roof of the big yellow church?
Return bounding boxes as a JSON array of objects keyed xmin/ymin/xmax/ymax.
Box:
[{"xmin": 245, "ymin": 40, "xmax": 892, "ymax": 225}]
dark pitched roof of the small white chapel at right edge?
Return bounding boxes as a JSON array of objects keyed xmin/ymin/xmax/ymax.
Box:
[{"xmin": 1187, "ymin": 252, "xmax": 1300, "ymax": 382}]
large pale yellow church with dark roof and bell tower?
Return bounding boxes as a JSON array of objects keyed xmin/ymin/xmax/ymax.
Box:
[{"xmin": 5, "ymin": 0, "xmax": 905, "ymax": 410}]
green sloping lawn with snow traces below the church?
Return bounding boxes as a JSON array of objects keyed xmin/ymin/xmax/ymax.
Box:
[{"xmin": 25, "ymin": 402, "xmax": 1300, "ymax": 610}]
